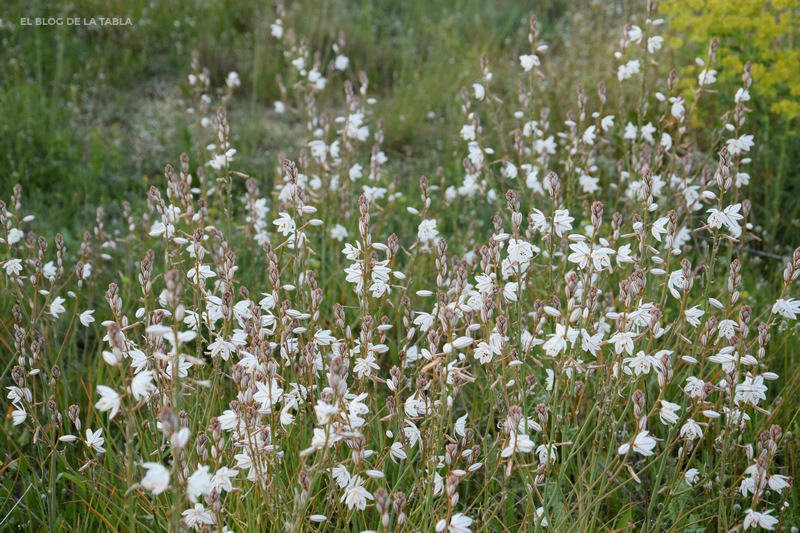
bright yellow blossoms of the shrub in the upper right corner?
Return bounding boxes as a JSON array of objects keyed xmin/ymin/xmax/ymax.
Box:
[{"xmin": 661, "ymin": 0, "xmax": 800, "ymax": 120}]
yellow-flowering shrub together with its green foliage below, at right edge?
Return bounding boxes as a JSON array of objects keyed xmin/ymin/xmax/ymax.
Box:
[{"xmin": 662, "ymin": 0, "xmax": 800, "ymax": 246}]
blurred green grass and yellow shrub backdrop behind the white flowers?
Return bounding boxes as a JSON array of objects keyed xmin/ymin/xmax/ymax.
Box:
[{"xmin": 0, "ymin": 0, "xmax": 800, "ymax": 244}]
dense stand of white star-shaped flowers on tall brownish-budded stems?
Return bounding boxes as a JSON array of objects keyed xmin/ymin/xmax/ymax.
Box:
[{"xmin": 0, "ymin": 3, "xmax": 800, "ymax": 533}]
